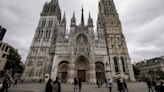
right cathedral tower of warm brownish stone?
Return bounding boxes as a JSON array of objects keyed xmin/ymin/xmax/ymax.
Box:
[{"xmin": 99, "ymin": 0, "xmax": 135, "ymax": 81}]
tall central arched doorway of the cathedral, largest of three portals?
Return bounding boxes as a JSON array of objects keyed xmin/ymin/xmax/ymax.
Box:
[{"xmin": 75, "ymin": 56, "xmax": 89, "ymax": 82}]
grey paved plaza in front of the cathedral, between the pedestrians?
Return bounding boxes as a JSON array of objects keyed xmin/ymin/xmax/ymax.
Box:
[{"xmin": 9, "ymin": 82, "xmax": 148, "ymax": 92}]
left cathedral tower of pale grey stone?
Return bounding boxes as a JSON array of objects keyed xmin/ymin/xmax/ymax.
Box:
[{"xmin": 23, "ymin": 0, "xmax": 61, "ymax": 80}]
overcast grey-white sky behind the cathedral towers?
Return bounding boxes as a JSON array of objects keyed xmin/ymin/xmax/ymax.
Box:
[{"xmin": 0, "ymin": 0, "xmax": 164, "ymax": 62}]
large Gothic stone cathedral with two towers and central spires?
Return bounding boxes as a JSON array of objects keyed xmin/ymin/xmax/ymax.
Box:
[{"xmin": 23, "ymin": 0, "xmax": 135, "ymax": 83}]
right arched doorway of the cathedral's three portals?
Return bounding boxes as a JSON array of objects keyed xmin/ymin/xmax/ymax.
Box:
[{"xmin": 96, "ymin": 62, "xmax": 105, "ymax": 80}]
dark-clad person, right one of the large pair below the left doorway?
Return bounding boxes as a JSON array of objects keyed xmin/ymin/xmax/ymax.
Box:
[{"xmin": 52, "ymin": 77, "xmax": 61, "ymax": 92}]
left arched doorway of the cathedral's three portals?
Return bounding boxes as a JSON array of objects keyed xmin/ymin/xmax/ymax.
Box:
[{"xmin": 58, "ymin": 61, "xmax": 68, "ymax": 82}]
